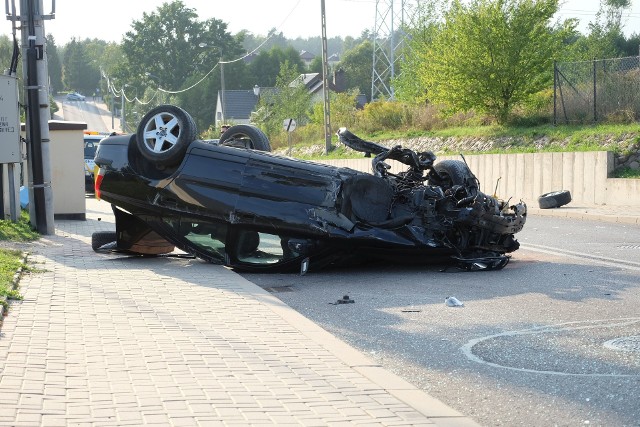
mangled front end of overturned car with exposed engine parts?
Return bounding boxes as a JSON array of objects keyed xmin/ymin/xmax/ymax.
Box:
[{"xmin": 338, "ymin": 129, "xmax": 527, "ymax": 268}]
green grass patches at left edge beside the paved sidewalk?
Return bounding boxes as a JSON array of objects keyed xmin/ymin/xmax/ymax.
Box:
[{"xmin": 0, "ymin": 211, "xmax": 40, "ymax": 306}]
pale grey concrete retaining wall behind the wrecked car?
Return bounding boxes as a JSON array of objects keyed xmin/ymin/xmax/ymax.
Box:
[{"xmin": 322, "ymin": 151, "xmax": 640, "ymax": 207}]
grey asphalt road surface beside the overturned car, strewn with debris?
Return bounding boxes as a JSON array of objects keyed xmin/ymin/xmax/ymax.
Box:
[{"xmin": 244, "ymin": 217, "xmax": 640, "ymax": 426}]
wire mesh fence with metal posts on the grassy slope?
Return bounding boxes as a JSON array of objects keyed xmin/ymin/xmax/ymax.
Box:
[{"xmin": 553, "ymin": 56, "xmax": 640, "ymax": 124}]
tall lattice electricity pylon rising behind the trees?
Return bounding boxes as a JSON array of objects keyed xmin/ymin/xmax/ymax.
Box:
[{"xmin": 371, "ymin": 0, "xmax": 421, "ymax": 100}]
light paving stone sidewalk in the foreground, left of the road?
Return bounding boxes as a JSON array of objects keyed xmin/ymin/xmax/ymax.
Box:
[{"xmin": 0, "ymin": 199, "xmax": 476, "ymax": 426}]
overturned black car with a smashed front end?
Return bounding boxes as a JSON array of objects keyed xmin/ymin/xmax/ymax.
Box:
[{"xmin": 92, "ymin": 105, "xmax": 527, "ymax": 273}]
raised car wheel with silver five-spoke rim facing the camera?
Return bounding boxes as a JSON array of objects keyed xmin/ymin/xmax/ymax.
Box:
[{"xmin": 136, "ymin": 105, "xmax": 198, "ymax": 166}]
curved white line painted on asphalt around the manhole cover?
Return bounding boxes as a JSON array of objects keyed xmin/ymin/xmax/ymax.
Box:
[{"xmin": 461, "ymin": 317, "xmax": 640, "ymax": 378}]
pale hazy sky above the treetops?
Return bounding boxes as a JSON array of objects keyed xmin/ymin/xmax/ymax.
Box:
[{"xmin": 8, "ymin": 0, "xmax": 640, "ymax": 45}]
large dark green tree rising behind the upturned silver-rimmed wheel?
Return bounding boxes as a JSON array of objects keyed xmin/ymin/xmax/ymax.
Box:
[{"xmin": 121, "ymin": 0, "xmax": 246, "ymax": 132}]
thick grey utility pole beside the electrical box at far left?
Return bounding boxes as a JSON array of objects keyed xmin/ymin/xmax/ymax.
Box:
[{"xmin": 16, "ymin": 0, "xmax": 55, "ymax": 234}]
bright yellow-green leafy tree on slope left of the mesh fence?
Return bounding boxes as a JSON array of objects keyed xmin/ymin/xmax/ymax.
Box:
[{"xmin": 417, "ymin": 0, "xmax": 574, "ymax": 123}]
